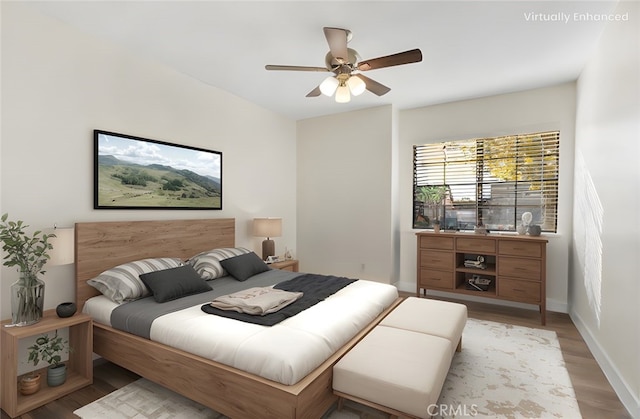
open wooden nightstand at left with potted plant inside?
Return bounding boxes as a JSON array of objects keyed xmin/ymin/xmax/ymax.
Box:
[{"xmin": 0, "ymin": 310, "xmax": 93, "ymax": 418}]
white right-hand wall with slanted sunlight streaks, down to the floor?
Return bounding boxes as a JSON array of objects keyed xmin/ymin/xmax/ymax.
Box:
[{"xmin": 570, "ymin": 2, "xmax": 640, "ymax": 418}]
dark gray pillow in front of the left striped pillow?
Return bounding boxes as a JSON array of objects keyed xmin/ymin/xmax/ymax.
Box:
[{"xmin": 140, "ymin": 265, "xmax": 211, "ymax": 303}]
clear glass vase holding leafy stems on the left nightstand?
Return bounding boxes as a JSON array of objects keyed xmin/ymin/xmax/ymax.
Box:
[{"xmin": 11, "ymin": 272, "xmax": 44, "ymax": 326}]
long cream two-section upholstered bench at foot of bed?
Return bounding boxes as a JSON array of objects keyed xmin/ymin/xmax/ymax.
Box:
[{"xmin": 333, "ymin": 297, "xmax": 467, "ymax": 418}]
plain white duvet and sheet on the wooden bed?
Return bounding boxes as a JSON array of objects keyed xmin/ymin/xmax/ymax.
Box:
[{"xmin": 84, "ymin": 280, "xmax": 398, "ymax": 385}]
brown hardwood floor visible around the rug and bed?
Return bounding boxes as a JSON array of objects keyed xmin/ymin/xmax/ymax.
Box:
[{"xmin": 0, "ymin": 296, "xmax": 631, "ymax": 419}]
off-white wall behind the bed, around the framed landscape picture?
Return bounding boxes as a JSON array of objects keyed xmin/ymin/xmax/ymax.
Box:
[{"xmin": 0, "ymin": 2, "xmax": 296, "ymax": 319}]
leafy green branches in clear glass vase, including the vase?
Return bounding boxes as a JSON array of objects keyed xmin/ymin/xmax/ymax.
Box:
[{"xmin": 0, "ymin": 214, "xmax": 55, "ymax": 326}]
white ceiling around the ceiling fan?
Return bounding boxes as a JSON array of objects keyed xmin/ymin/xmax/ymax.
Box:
[{"xmin": 26, "ymin": 0, "xmax": 617, "ymax": 120}]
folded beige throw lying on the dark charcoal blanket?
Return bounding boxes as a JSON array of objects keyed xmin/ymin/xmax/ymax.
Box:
[{"xmin": 210, "ymin": 287, "xmax": 303, "ymax": 316}]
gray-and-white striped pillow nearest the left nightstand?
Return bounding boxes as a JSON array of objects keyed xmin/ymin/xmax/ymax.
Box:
[{"xmin": 87, "ymin": 258, "xmax": 183, "ymax": 304}]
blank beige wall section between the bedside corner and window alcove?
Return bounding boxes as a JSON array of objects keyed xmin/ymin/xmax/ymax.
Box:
[{"xmin": 297, "ymin": 104, "xmax": 397, "ymax": 283}]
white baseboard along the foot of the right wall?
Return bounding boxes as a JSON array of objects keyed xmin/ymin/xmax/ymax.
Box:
[{"xmin": 569, "ymin": 311, "xmax": 640, "ymax": 419}]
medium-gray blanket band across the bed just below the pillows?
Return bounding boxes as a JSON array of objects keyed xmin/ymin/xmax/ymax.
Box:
[{"xmin": 111, "ymin": 269, "xmax": 300, "ymax": 339}]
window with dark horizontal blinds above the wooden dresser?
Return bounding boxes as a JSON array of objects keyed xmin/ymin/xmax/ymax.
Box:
[{"xmin": 413, "ymin": 131, "xmax": 560, "ymax": 233}]
